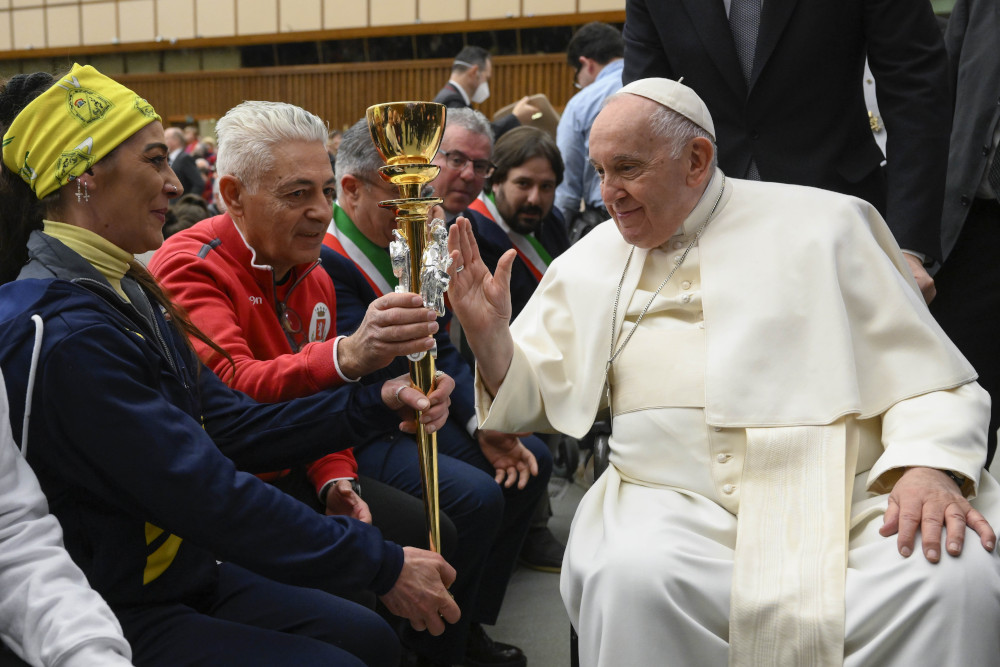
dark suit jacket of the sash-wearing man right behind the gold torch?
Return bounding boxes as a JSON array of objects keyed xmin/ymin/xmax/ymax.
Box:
[{"xmin": 320, "ymin": 246, "xmax": 476, "ymax": 432}]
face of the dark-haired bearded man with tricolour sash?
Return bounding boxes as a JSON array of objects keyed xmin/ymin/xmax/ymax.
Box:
[{"xmin": 493, "ymin": 156, "xmax": 556, "ymax": 234}]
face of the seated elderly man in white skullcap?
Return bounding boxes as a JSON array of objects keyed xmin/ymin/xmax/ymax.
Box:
[{"xmin": 590, "ymin": 95, "xmax": 700, "ymax": 248}]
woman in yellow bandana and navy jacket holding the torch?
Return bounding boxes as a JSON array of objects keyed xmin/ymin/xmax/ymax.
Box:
[{"xmin": 0, "ymin": 65, "xmax": 458, "ymax": 667}]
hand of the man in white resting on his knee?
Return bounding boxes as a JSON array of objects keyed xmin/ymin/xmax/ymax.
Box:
[{"xmin": 879, "ymin": 468, "xmax": 997, "ymax": 563}]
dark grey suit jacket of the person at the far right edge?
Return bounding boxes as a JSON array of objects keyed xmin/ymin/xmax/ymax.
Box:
[{"xmin": 941, "ymin": 0, "xmax": 1000, "ymax": 259}]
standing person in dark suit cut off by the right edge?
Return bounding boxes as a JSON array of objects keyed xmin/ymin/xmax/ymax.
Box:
[{"xmin": 931, "ymin": 0, "xmax": 1000, "ymax": 465}]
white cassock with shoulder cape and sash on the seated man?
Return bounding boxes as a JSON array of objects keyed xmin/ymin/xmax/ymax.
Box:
[{"xmin": 477, "ymin": 171, "xmax": 1000, "ymax": 667}]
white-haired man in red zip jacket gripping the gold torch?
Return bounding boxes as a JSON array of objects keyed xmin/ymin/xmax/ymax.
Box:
[{"xmin": 150, "ymin": 101, "xmax": 455, "ymax": 632}]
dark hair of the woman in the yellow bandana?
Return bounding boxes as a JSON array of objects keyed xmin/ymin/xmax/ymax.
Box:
[{"xmin": 0, "ymin": 72, "xmax": 236, "ymax": 374}]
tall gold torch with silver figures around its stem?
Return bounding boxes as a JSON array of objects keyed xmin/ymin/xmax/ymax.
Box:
[{"xmin": 366, "ymin": 102, "xmax": 451, "ymax": 553}]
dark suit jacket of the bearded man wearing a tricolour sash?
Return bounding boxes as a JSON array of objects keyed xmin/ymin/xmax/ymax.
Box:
[{"xmin": 462, "ymin": 208, "xmax": 569, "ymax": 320}]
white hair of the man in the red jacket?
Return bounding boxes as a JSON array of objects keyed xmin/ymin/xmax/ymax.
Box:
[{"xmin": 215, "ymin": 100, "xmax": 328, "ymax": 193}]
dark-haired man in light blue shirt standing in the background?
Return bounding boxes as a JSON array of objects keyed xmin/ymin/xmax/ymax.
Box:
[{"xmin": 556, "ymin": 21, "xmax": 625, "ymax": 240}]
